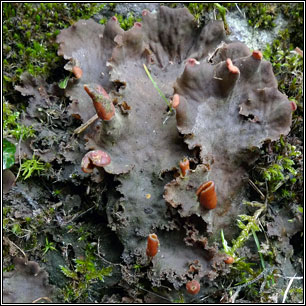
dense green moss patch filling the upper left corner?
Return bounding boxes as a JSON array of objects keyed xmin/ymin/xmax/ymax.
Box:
[{"xmin": 3, "ymin": 3, "xmax": 104, "ymax": 92}]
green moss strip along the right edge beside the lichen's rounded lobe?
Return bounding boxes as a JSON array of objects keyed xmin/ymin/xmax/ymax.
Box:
[{"xmin": 254, "ymin": 3, "xmax": 304, "ymax": 203}]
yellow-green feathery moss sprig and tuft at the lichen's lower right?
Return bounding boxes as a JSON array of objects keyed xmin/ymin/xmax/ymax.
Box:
[{"xmin": 221, "ymin": 201, "xmax": 276, "ymax": 301}]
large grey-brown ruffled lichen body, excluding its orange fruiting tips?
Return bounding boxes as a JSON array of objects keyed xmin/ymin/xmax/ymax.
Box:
[{"xmin": 53, "ymin": 7, "xmax": 292, "ymax": 289}]
